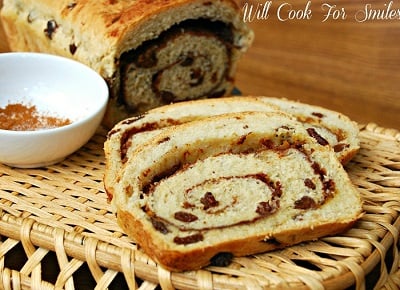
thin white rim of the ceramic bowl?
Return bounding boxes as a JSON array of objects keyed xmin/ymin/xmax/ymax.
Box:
[{"xmin": 0, "ymin": 51, "xmax": 110, "ymax": 136}]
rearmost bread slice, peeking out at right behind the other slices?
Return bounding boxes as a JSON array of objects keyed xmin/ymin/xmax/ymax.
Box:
[{"xmin": 256, "ymin": 97, "xmax": 360, "ymax": 164}]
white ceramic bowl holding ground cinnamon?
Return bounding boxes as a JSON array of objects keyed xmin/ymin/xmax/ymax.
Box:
[{"xmin": 0, "ymin": 52, "xmax": 109, "ymax": 168}]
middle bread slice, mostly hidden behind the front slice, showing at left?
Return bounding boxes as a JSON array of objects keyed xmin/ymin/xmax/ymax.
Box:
[{"xmin": 104, "ymin": 97, "xmax": 279, "ymax": 199}]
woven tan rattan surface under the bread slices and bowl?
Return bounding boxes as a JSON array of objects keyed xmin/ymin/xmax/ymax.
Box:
[{"xmin": 0, "ymin": 124, "xmax": 400, "ymax": 289}]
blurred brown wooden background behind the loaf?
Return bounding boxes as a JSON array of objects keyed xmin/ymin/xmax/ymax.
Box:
[{"xmin": 0, "ymin": 0, "xmax": 400, "ymax": 129}]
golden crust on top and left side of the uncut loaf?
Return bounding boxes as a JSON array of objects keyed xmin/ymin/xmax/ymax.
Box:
[{"xmin": 2, "ymin": 0, "xmax": 248, "ymax": 77}]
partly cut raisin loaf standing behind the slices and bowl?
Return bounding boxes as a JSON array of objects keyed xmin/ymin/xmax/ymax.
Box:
[{"xmin": 1, "ymin": 0, "xmax": 253, "ymax": 126}]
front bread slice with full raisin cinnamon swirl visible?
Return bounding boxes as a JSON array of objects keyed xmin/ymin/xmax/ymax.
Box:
[{"xmin": 112, "ymin": 112, "xmax": 362, "ymax": 271}]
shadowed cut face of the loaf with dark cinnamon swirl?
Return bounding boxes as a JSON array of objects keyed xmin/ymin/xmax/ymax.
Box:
[{"xmin": 119, "ymin": 19, "xmax": 236, "ymax": 113}]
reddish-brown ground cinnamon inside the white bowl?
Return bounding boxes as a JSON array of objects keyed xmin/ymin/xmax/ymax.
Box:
[{"xmin": 0, "ymin": 103, "xmax": 71, "ymax": 131}]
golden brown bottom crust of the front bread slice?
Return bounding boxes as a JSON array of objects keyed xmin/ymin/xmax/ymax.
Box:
[{"xmin": 117, "ymin": 210, "xmax": 360, "ymax": 271}]
